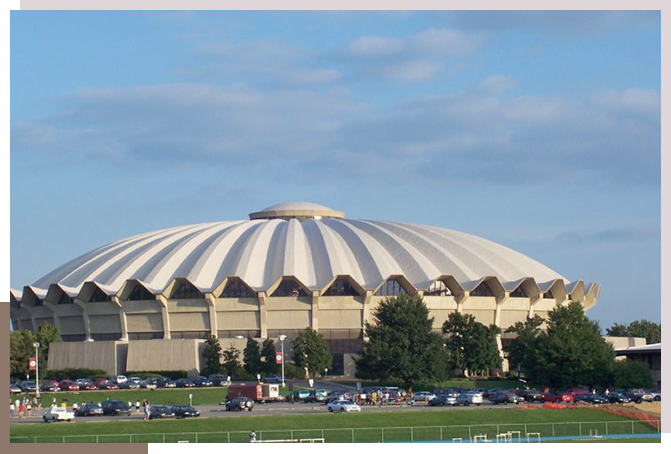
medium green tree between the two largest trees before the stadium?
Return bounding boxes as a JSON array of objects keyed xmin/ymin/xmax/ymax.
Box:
[{"xmin": 443, "ymin": 312, "xmax": 502, "ymax": 374}]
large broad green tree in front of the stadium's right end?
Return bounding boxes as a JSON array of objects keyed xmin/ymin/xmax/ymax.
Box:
[{"xmin": 525, "ymin": 301, "xmax": 615, "ymax": 388}]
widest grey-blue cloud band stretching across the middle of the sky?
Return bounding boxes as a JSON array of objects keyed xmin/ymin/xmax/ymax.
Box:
[{"xmin": 10, "ymin": 76, "xmax": 661, "ymax": 185}]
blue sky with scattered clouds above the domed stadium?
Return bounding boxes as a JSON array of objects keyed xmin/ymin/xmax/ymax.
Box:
[{"xmin": 10, "ymin": 11, "xmax": 661, "ymax": 328}]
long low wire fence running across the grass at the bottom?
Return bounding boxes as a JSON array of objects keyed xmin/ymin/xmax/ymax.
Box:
[{"xmin": 10, "ymin": 420, "xmax": 662, "ymax": 444}]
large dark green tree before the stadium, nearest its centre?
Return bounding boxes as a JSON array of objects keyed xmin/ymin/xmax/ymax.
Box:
[{"xmin": 355, "ymin": 295, "xmax": 447, "ymax": 388}]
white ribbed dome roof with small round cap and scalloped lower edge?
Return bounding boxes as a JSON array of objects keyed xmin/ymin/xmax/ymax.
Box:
[{"xmin": 33, "ymin": 202, "xmax": 563, "ymax": 294}]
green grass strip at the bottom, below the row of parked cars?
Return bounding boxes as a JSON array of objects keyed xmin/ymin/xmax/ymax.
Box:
[{"xmin": 10, "ymin": 409, "xmax": 656, "ymax": 442}]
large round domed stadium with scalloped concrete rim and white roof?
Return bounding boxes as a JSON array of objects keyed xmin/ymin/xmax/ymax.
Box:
[{"xmin": 10, "ymin": 202, "xmax": 599, "ymax": 373}]
